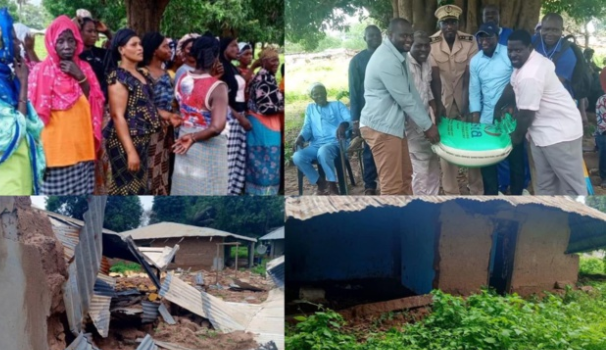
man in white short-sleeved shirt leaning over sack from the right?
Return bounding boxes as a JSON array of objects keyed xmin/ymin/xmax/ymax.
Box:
[{"xmin": 495, "ymin": 30, "xmax": 588, "ymax": 196}]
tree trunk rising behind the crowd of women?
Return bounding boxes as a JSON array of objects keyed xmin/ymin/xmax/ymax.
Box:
[{"xmin": 125, "ymin": 0, "xmax": 170, "ymax": 35}]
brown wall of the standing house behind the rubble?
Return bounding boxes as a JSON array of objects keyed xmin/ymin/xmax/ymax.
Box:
[{"xmin": 145, "ymin": 237, "xmax": 224, "ymax": 269}]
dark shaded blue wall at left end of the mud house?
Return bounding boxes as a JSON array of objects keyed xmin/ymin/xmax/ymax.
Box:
[{"xmin": 285, "ymin": 208, "xmax": 402, "ymax": 282}]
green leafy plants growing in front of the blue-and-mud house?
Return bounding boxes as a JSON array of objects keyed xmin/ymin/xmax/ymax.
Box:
[{"xmin": 286, "ymin": 282, "xmax": 606, "ymax": 350}]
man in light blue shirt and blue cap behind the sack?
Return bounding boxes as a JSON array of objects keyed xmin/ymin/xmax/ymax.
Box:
[{"xmin": 469, "ymin": 22, "xmax": 525, "ymax": 196}]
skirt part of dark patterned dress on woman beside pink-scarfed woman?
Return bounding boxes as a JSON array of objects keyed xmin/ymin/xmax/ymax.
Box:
[{"xmin": 106, "ymin": 132, "xmax": 150, "ymax": 196}]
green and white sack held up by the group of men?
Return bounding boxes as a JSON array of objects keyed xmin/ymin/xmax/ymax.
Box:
[{"xmin": 432, "ymin": 113, "xmax": 516, "ymax": 168}]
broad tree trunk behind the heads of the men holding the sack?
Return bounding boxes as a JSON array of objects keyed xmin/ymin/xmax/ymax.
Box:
[{"xmin": 392, "ymin": 0, "xmax": 541, "ymax": 34}]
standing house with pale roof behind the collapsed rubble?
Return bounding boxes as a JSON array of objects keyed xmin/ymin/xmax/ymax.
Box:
[{"xmin": 120, "ymin": 222, "xmax": 257, "ymax": 269}]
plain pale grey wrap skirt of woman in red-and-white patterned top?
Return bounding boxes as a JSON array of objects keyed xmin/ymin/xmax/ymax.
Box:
[{"xmin": 171, "ymin": 126, "xmax": 228, "ymax": 196}]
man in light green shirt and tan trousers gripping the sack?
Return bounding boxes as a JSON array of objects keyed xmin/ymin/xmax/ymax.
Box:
[{"xmin": 360, "ymin": 18, "xmax": 440, "ymax": 195}]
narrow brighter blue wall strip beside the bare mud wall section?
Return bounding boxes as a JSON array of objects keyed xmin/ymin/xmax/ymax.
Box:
[{"xmin": 401, "ymin": 203, "xmax": 440, "ymax": 294}]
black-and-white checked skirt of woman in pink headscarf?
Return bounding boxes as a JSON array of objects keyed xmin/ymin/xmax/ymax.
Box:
[{"xmin": 40, "ymin": 161, "xmax": 95, "ymax": 196}]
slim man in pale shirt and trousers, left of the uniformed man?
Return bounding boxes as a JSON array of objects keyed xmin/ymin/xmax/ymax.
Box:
[{"xmin": 405, "ymin": 30, "xmax": 444, "ymax": 196}]
